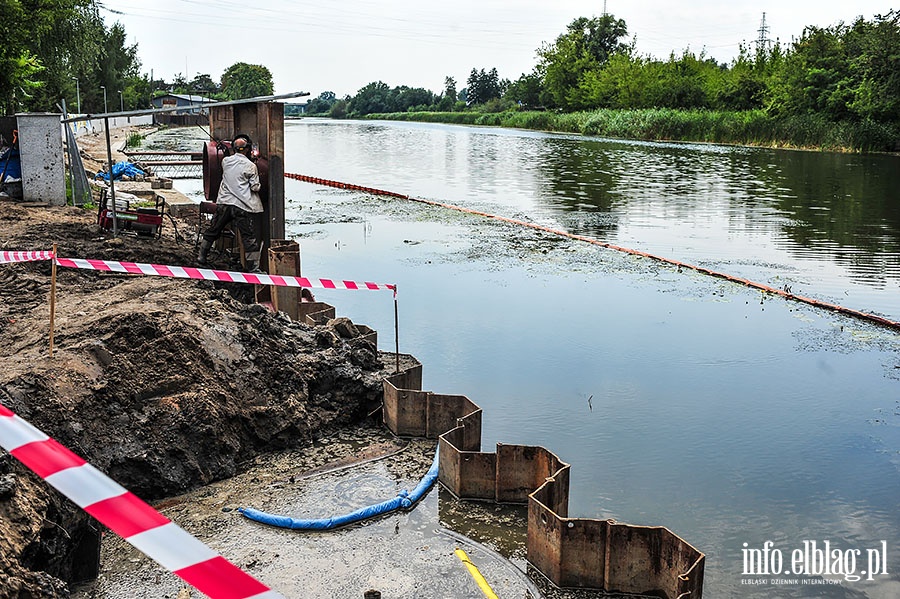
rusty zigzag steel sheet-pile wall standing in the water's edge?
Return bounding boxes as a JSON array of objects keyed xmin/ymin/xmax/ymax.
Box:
[{"xmin": 384, "ymin": 365, "xmax": 706, "ymax": 599}]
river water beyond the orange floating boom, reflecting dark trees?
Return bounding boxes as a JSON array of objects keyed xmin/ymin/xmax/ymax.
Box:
[{"xmin": 286, "ymin": 121, "xmax": 900, "ymax": 317}]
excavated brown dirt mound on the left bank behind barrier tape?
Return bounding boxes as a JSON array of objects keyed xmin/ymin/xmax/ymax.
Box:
[{"xmin": 0, "ymin": 199, "xmax": 392, "ymax": 599}]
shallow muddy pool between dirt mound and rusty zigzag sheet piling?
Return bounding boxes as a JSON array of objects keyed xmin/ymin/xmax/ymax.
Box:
[{"xmin": 73, "ymin": 427, "xmax": 548, "ymax": 599}]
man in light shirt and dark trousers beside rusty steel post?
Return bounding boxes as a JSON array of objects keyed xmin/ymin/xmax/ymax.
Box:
[{"xmin": 197, "ymin": 133, "xmax": 263, "ymax": 272}]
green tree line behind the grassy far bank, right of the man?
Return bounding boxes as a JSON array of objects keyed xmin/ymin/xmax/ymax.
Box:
[{"xmin": 309, "ymin": 9, "xmax": 900, "ymax": 129}]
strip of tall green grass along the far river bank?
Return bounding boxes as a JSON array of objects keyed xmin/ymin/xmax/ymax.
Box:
[{"xmin": 365, "ymin": 108, "xmax": 900, "ymax": 152}]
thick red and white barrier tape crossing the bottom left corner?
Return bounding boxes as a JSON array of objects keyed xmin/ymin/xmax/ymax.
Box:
[{"xmin": 0, "ymin": 404, "xmax": 283, "ymax": 599}]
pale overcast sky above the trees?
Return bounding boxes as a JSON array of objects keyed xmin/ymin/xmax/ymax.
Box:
[{"xmin": 98, "ymin": 0, "xmax": 896, "ymax": 97}]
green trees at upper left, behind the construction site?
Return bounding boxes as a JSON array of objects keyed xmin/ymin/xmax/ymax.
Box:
[{"xmin": 0, "ymin": 0, "xmax": 274, "ymax": 114}]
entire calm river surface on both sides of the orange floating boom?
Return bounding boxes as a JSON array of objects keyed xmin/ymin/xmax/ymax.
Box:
[{"xmin": 176, "ymin": 119, "xmax": 900, "ymax": 599}]
